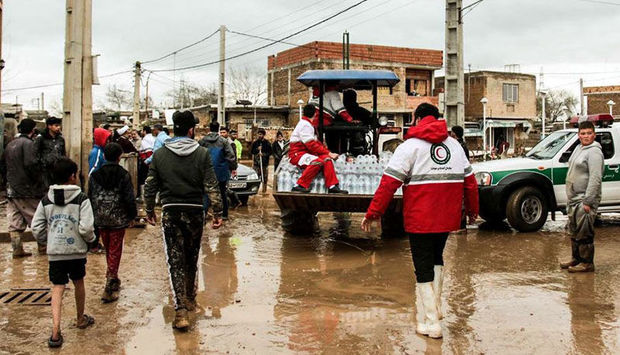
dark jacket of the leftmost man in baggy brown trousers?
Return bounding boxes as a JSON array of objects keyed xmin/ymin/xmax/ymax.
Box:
[{"xmin": 4, "ymin": 134, "xmax": 46, "ymax": 199}]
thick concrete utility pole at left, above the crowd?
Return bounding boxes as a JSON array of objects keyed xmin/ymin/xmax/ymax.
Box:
[{"xmin": 63, "ymin": 0, "xmax": 93, "ymax": 178}]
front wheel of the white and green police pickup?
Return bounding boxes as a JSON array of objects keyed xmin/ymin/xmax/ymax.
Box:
[{"xmin": 506, "ymin": 186, "xmax": 549, "ymax": 232}]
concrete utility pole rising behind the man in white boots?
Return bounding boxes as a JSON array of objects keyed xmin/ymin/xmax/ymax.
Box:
[{"xmin": 444, "ymin": 0, "xmax": 465, "ymax": 127}]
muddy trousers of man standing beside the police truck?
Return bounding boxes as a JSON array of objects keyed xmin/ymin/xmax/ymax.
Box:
[{"xmin": 568, "ymin": 202, "xmax": 596, "ymax": 264}]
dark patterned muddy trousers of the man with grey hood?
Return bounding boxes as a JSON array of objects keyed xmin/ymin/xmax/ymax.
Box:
[{"xmin": 161, "ymin": 207, "xmax": 204, "ymax": 309}]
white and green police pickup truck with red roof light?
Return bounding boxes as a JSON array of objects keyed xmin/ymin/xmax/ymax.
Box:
[{"xmin": 473, "ymin": 115, "xmax": 620, "ymax": 232}]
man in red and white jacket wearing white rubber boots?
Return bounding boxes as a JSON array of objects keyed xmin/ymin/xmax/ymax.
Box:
[{"xmin": 362, "ymin": 103, "xmax": 478, "ymax": 338}]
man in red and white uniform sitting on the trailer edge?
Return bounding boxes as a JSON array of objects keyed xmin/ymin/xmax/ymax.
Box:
[{"xmin": 288, "ymin": 104, "xmax": 349, "ymax": 194}]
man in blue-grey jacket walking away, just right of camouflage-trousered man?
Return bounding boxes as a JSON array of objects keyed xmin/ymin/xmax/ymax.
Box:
[{"xmin": 198, "ymin": 121, "xmax": 237, "ymax": 220}]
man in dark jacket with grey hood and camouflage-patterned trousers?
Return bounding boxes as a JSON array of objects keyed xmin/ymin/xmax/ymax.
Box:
[{"xmin": 144, "ymin": 111, "xmax": 222, "ymax": 330}]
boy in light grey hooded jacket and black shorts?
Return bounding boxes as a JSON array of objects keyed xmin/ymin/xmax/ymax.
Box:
[{"xmin": 32, "ymin": 157, "xmax": 95, "ymax": 348}]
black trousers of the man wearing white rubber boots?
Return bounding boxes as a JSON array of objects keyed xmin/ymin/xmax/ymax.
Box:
[{"xmin": 407, "ymin": 233, "xmax": 448, "ymax": 283}]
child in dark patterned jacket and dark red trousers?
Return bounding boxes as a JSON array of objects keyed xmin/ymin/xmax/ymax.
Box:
[{"xmin": 88, "ymin": 143, "xmax": 138, "ymax": 303}]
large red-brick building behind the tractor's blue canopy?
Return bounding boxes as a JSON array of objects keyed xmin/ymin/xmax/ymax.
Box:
[{"xmin": 267, "ymin": 41, "xmax": 443, "ymax": 126}]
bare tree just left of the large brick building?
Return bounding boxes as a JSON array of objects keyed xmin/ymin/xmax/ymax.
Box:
[{"xmin": 226, "ymin": 67, "xmax": 267, "ymax": 105}]
